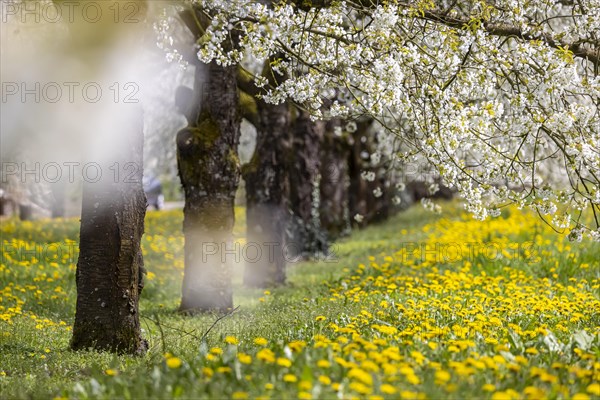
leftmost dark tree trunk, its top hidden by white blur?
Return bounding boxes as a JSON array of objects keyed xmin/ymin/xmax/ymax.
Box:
[{"xmin": 71, "ymin": 108, "xmax": 147, "ymax": 354}]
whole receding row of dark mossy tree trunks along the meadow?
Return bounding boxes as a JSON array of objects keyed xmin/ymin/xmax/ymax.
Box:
[{"xmin": 72, "ymin": 9, "xmax": 398, "ymax": 353}]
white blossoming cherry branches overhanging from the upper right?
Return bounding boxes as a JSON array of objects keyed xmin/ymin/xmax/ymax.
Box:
[{"xmin": 170, "ymin": 0, "xmax": 600, "ymax": 240}]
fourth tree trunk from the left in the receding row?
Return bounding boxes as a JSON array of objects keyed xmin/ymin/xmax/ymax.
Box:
[{"xmin": 286, "ymin": 110, "xmax": 327, "ymax": 258}]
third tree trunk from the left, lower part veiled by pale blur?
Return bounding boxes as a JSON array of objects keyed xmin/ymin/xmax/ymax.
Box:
[{"xmin": 243, "ymin": 100, "xmax": 290, "ymax": 287}]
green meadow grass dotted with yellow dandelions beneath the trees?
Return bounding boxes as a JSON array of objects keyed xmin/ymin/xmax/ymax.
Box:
[{"xmin": 0, "ymin": 204, "xmax": 600, "ymax": 399}]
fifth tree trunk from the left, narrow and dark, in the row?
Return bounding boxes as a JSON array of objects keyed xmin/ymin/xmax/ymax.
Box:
[{"xmin": 319, "ymin": 120, "xmax": 350, "ymax": 239}]
